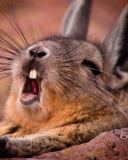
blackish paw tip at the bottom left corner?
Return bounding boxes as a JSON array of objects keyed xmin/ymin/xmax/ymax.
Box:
[{"xmin": 0, "ymin": 137, "xmax": 17, "ymax": 158}]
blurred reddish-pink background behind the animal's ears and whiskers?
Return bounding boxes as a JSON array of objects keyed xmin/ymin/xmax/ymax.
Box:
[{"xmin": 0, "ymin": 0, "xmax": 128, "ymax": 119}]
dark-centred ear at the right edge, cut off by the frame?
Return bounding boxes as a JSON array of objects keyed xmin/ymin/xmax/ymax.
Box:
[{"xmin": 101, "ymin": 4, "xmax": 128, "ymax": 89}]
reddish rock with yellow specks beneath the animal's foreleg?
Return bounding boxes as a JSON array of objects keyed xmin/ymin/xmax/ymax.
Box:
[{"xmin": 1, "ymin": 128, "xmax": 128, "ymax": 160}]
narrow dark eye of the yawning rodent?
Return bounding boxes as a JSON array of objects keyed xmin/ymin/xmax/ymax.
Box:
[{"xmin": 82, "ymin": 60, "xmax": 100, "ymax": 75}]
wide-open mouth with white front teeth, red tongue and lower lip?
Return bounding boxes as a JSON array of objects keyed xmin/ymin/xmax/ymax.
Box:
[{"xmin": 20, "ymin": 70, "xmax": 41, "ymax": 105}]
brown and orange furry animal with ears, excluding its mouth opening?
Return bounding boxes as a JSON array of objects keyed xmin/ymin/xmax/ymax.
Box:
[{"xmin": 0, "ymin": 0, "xmax": 128, "ymax": 157}]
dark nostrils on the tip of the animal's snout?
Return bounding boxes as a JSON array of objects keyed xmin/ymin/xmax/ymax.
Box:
[{"xmin": 27, "ymin": 50, "xmax": 46, "ymax": 60}]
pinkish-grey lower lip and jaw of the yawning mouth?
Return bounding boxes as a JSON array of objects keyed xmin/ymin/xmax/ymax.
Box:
[{"xmin": 19, "ymin": 93, "xmax": 39, "ymax": 106}]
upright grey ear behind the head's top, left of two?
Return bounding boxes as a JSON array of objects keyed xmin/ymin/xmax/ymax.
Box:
[{"xmin": 60, "ymin": 0, "xmax": 92, "ymax": 39}]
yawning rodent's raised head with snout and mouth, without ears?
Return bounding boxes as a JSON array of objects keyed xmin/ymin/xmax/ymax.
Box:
[{"xmin": 12, "ymin": 38, "xmax": 102, "ymax": 112}]
